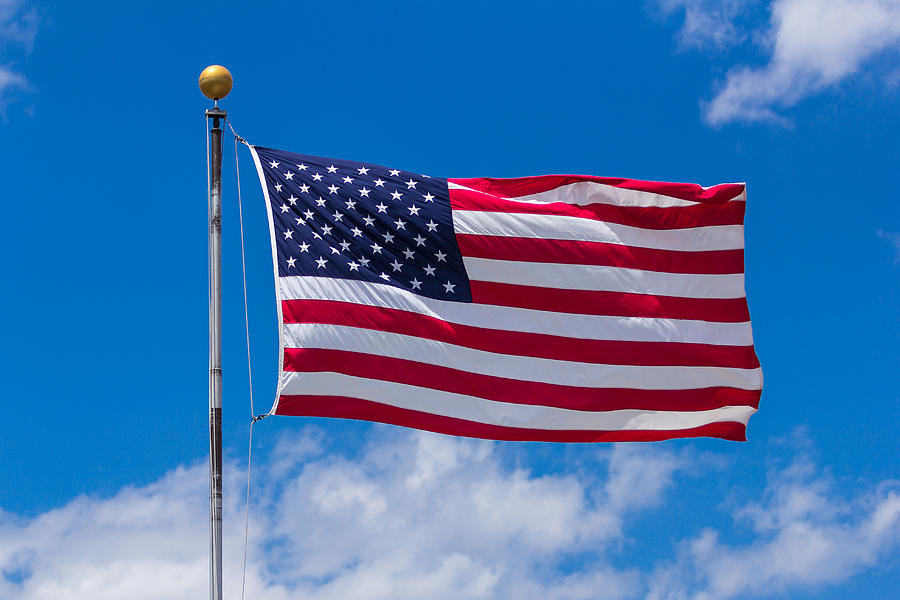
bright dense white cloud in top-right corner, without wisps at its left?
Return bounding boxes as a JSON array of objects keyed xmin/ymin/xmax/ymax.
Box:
[{"xmin": 705, "ymin": 0, "xmax": 900, "ymax": 125}]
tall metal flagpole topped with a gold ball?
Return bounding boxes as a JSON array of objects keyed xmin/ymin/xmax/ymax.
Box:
[{"xmin": 200, "ymin": 65, "xmax": 232, "ymax": 600}]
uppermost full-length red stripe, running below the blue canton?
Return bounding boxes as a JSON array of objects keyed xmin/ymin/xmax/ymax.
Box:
[{"xmin": 281, "ymin": 300, "xmax": 759, "ymax": 369}]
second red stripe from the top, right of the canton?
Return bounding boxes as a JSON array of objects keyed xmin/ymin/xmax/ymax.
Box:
[{"xmin": 450, "ymin": 189, "xmax": 746, "ymax": 229}]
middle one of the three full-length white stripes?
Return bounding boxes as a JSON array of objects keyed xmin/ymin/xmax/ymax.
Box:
[{"xmin": 284, "ymin": 323, "xmax": 762, "ymax": 390}]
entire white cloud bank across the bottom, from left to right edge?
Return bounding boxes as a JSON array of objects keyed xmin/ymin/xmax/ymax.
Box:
[{"xmin": 0, "ymin": 429, "xmax": 900, "ymax": 600}]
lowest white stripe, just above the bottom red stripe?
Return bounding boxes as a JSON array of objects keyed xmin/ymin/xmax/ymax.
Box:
[{"xmin": 281, "ymin": 373, "xmax": 756, "ymax": 431}]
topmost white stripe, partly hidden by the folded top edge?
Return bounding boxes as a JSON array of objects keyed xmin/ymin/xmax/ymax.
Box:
[{"xmin": 448, "ymin": 181, "xmax": 746, "ymax": 208}]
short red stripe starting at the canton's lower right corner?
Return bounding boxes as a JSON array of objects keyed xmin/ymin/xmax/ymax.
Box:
[{"xmin": 469, "ymin": 281, "xmax": 750, "ymax": 323}]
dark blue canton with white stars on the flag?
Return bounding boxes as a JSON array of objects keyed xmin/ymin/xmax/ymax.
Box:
[{"xmin": 255, "ymin": 146, "xmax": 472, "ymax": 302}]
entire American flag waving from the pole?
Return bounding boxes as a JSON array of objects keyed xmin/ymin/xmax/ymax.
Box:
[{"xmin": 251, "ymin": 146, "xmax": 762, "ymax": 442}]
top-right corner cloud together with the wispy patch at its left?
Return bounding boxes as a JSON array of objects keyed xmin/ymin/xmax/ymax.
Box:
[{"xmin": 658, "ymin": 0, "xmax": 900, "ymax": 126}]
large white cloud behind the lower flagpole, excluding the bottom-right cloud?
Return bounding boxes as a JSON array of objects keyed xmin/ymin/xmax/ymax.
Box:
[{"xmin": 0, "ymin": 431, "xmax": 684, "ymax": 600}]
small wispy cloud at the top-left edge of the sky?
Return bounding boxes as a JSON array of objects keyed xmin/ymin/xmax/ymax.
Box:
[{"xmin": 0, "ymin": 0, "xmax": 38, "ymax": 115}]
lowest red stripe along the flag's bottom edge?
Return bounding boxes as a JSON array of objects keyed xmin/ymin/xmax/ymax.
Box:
[{"xmin": 275, "ymin": 396, "xmax": 747, "ymax": 442}]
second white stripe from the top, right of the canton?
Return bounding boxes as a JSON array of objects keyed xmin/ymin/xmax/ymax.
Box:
[{"xmin": 453, "ymin": 210, "xmax": 744, "ymax": 252}]
